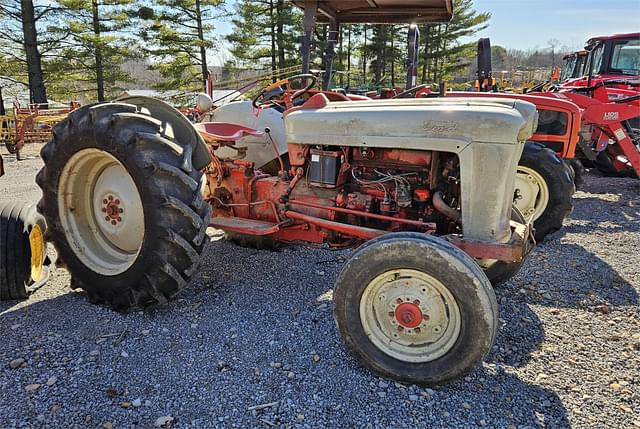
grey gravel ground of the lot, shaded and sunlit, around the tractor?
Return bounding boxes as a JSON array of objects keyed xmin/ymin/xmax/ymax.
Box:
[{"xmin": 0, "ymin": 152, "xmax": 640, "ymax": 428}]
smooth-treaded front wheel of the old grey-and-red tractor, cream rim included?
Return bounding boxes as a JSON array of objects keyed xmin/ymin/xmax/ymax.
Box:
[{"xmin": 333, "ymin": 233, "xmax": 498, "ymax": 385}]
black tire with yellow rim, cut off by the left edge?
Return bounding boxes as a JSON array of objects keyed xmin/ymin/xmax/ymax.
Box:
[{"xmin": 0, "ymin": 203, "xmax": 47, "ymax": 301}]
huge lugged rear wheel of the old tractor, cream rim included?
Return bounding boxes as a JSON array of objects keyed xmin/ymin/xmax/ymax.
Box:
[{"xmin": 36, "ymin": 103, "xmax": 211, "ymax": 310}]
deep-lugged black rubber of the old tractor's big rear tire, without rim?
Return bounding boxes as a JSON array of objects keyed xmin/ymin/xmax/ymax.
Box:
[{"xmin": 36, "ymin": 103, "xmax": 211, "ymax": 310}]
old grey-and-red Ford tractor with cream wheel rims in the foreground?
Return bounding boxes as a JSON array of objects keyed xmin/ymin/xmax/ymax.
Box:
[{"xmin": 28, "ymin": 0, "xmax": 537, "ymax": 384}]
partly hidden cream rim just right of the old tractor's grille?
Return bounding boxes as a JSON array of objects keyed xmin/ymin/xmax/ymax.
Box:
[{"xmin": 514, "ymin": 165, "xmax": 549, "ymax": 221}]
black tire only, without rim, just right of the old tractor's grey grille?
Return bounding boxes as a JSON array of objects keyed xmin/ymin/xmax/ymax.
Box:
[{"xmin": 518, "ymin": 142, "xmax": 576, "ymax": 243}]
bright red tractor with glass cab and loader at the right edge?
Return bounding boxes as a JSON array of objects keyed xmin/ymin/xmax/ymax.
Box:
[{"xmin": 532, "ymin": 33, "xmax": 640, "ymax": 176}]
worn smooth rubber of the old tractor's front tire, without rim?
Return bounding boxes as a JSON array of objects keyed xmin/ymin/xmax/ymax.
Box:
[{"xmin": 333, "ymin": 232, "xmax": 498, "ymax": 385}]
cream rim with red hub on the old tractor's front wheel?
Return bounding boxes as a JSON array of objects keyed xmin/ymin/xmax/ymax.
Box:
[{"xmin": 360, "ymin": 269, "xmax": 462, "ymax": 363}]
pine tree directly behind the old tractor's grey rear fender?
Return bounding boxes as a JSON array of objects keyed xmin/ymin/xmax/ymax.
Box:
[{"xmin": 140, "ymin": 0, "xmax": 223, "ymax": 91}]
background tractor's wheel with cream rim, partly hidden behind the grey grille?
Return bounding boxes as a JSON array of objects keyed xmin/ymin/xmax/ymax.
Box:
[{"xmin": 513, "ymin": 142, "xmax": 575, "ymax": 242}]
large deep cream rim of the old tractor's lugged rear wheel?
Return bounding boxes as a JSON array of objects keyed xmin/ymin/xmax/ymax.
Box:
[{"xmin": 58, "ymin": 149, "xmax": 144, "ymax": 276}]
